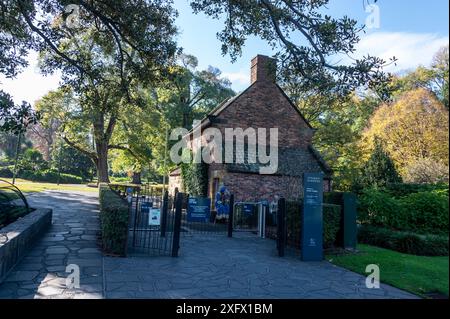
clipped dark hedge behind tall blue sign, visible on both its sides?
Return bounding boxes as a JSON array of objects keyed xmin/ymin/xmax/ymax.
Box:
[{"xmin": 286, "ymin": 201, "xmax": 342, "ymax": 248}]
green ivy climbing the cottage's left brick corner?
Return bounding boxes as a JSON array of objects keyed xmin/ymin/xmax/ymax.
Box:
[{"xmin": 181, "ymin": 150, "xmax": 208, "ymax": 197}]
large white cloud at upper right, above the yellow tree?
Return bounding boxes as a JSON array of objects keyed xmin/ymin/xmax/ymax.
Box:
[{"xmin": 355, "ymin": 32, "xmax": 449, "ymax": 72}]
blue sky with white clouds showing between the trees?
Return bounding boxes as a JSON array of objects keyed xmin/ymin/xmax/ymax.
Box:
[{"xmin": 0, "ymin": 0, "xmax": 449, "ymax": 103}]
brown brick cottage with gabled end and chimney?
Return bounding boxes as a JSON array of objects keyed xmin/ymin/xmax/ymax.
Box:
[{"xmin": 169, "ymin": 55, "xmax": 332, "ymax": 205}]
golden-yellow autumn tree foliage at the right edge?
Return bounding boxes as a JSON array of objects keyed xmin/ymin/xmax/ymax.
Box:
[{"xmin": 361, "ymin": 89, "xmax": 449, "ymax": 174}]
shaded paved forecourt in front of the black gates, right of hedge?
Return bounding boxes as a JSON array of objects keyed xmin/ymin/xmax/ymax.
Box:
[{"xmin": 104, "ymin": 233, "xmax": 417, "ymax": 299}]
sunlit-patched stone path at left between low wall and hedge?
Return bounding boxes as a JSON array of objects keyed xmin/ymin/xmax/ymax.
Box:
[{"xmin": 0, "ymin": 191, "xmax": 103, "ymax": 299}]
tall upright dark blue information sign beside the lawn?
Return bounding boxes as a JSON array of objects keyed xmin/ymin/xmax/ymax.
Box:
[{"xmin": 301, "ymin": 173, "xmax": 323, "ymax": 261}]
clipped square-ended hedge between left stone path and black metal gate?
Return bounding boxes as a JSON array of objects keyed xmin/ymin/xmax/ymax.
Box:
[{"xmin": 99, "ymin": 183, "xmax": 128, "ymax": 256}]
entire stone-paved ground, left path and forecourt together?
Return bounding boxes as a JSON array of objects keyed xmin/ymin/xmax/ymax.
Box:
[{"xmin": 0, "ymin": 191, "xmax": 417, "ymax": 299}]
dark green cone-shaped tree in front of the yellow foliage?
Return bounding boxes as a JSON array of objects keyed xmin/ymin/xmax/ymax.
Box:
[{"xmin": 358, "ymin": 139, "xmax": 402, "ymax": 187}]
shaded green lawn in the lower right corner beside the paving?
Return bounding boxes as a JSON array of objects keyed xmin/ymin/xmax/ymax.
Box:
[{"xmin": 326, "ymin": 245, "xmax": 449, "ymax": 297}]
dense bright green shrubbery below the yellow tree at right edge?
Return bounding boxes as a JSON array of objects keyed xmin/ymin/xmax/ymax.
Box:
[{"xmin": 358, "ymin": 189, "xmax": 449, "ymax": 234}]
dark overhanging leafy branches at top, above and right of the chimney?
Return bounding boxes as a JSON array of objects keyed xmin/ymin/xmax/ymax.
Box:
[{"xmin": 191, "ymin": 0, "xmax": 390, "ymax": 95}]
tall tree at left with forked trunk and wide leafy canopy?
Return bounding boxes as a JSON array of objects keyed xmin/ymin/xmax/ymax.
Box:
[{"xmin": 0, "ymin": 0, "xmax": 176, "ymax": 181}]
